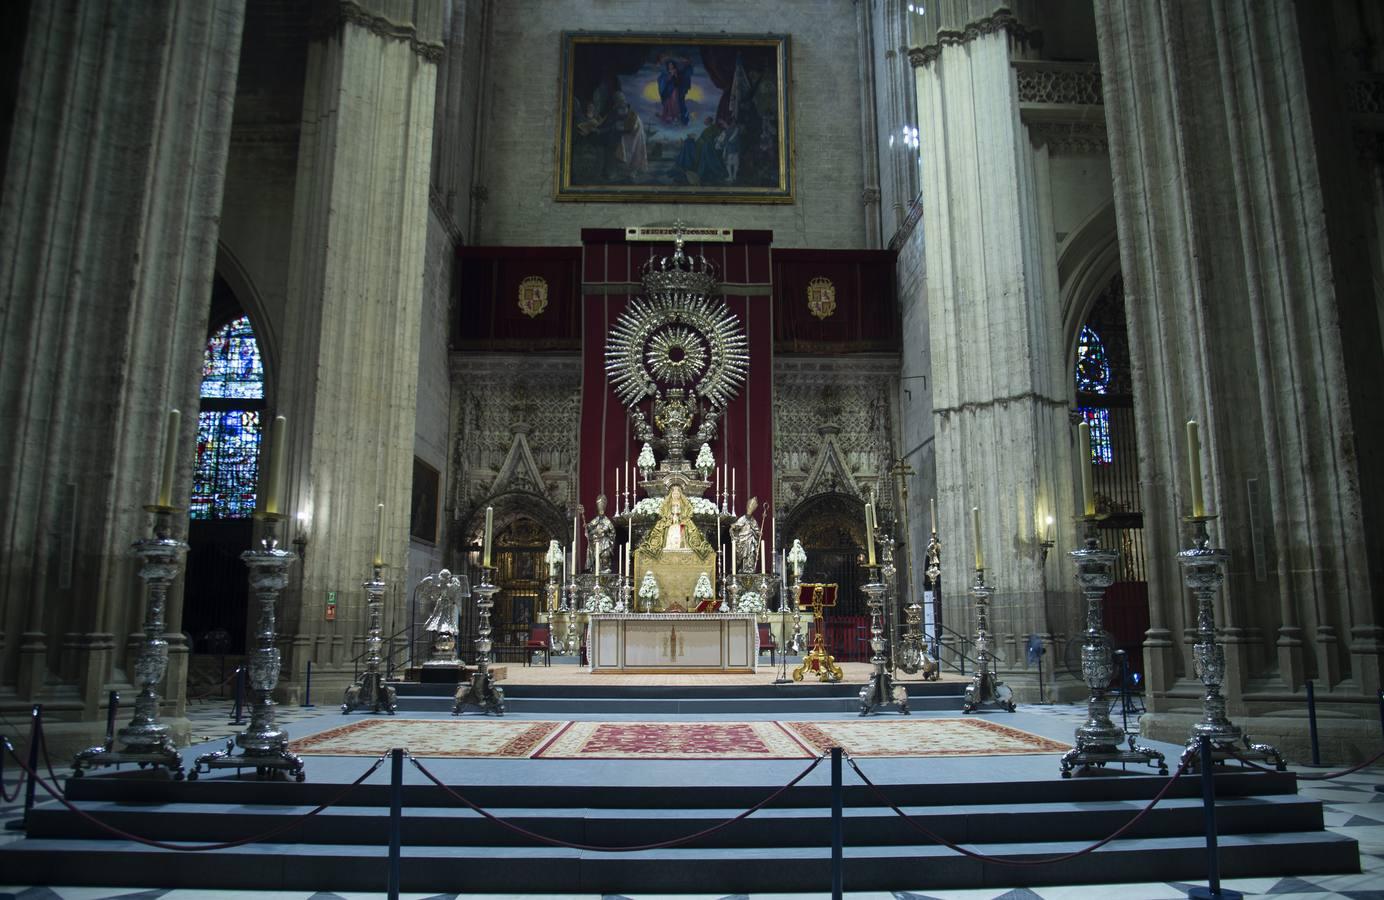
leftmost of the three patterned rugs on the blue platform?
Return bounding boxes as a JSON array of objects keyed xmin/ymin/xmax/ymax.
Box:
[{"xmin": 289, "ymin": 719, "xmax": 566, "ymax": 759}]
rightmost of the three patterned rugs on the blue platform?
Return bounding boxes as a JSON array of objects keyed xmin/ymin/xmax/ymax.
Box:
[{"xmin": 783, "ymin": 719, "xmax": 1071, "ymax": 756}]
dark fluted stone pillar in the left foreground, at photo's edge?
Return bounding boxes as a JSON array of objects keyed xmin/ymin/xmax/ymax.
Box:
[{"xmin": 0, "ymin": 0, "xmax": 244, "ymax": 756}]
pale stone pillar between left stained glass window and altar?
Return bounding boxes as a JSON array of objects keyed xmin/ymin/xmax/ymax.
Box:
[{"xmin": 280, "ymin": 0, "xmax": 443, "ymax": 699}]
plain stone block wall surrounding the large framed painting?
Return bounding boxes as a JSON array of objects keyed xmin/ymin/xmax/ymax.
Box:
[{"xmin": 471, "ymin": 0, "xmax": 866, "ymax": 248}]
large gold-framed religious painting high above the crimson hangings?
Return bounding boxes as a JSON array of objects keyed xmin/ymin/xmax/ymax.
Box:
[{"xmin": 556, "ymin": 32, "xmax": 793, "ymax": 204}]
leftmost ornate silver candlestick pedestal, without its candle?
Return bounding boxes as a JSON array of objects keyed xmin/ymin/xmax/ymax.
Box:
[{"xmin": 72, "ymin": 505, "xmax": 187, "ymax": 781}]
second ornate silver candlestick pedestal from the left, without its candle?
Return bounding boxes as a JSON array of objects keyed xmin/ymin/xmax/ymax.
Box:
[{"xmin": 188, "ymin": 514, "xmax": 304, "ymax": 781}]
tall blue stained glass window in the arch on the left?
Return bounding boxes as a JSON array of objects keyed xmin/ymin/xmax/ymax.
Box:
[{"xmin": 188, "ymin": 316, "xmax": 264, "ymax": 519}]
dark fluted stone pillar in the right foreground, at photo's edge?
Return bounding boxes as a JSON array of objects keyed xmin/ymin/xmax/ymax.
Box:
[{"xmin": 1096, "ymin": 0, "xmax": 1384, "ymax": 738}]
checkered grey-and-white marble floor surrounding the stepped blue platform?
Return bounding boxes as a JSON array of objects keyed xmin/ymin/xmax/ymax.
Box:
[{"xmin": 0, "ymin": 703, "xmax": 1384, "ymax": 900}]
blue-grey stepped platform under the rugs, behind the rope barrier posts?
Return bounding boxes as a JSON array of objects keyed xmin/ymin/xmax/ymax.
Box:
[{"xmin": 0, "ymin": 709, "xmax": 1359, "ymax": 896}]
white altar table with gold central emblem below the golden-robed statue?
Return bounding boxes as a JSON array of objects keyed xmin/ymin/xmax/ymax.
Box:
[{"xmin": 587, "ymin": 612, "xmax": 760, "ymax": 674}]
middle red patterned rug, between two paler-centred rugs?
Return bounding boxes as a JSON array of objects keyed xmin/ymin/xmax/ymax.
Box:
[{"xmin": 534, "ymin": 721, "xmax": 815, "ymax": 760}]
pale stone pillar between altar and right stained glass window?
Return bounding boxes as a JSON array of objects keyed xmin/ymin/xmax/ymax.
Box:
[{"xmin": 909, "ymin": 3, "xmax": 1081, "ymax": 699}]
